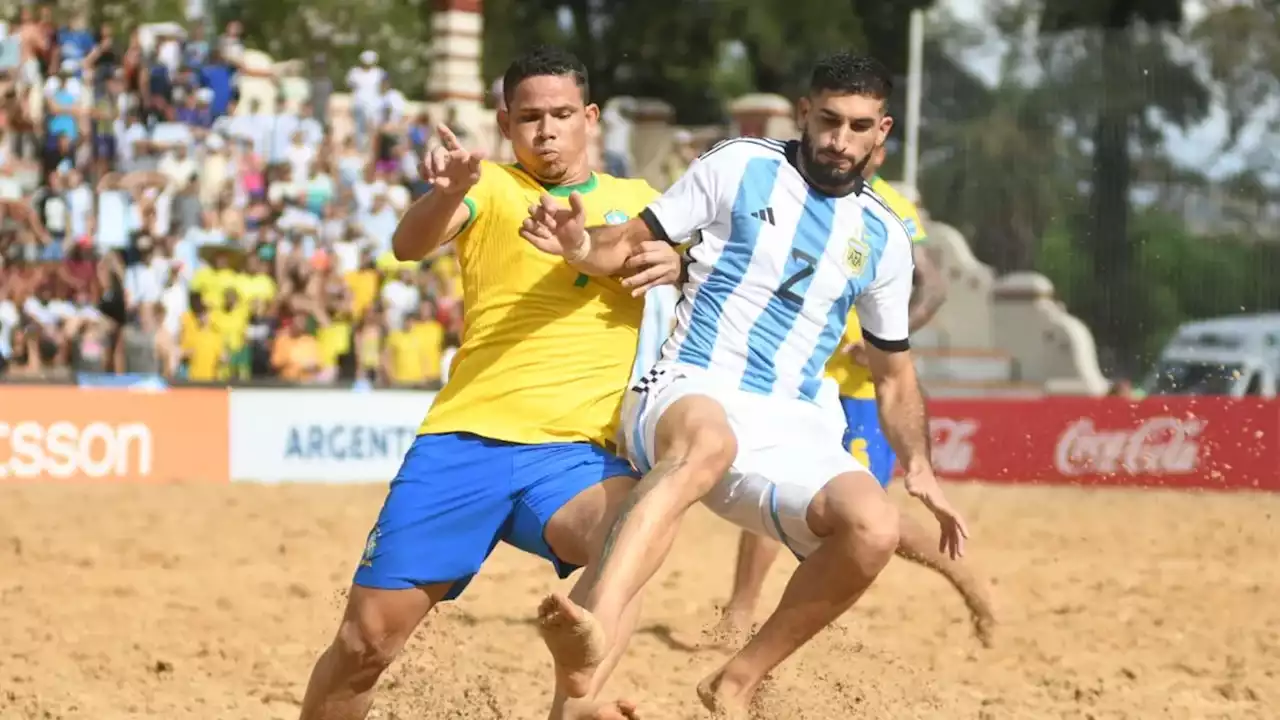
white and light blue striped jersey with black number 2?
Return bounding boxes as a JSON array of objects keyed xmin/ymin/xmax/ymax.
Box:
[{"xmin": 640, "ymin": 138, "xmax": 914, "ymax": 401}]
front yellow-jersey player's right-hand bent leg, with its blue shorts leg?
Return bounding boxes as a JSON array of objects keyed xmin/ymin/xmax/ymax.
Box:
[{"xmin": 507, "ymin": 443, "xmax": 650, "ymax": 720}]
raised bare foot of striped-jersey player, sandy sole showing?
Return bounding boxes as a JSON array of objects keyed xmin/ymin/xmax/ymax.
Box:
[{"xmin": 538, "ymin": 593, "xmax": 605, "ymax": 697}]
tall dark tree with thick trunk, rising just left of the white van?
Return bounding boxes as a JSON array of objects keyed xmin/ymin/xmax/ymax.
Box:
[{"xmin": 1039, "ymin": 0, "xmax": 1208, "ymax": 370}]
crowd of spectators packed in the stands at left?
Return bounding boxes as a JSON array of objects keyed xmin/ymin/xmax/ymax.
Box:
[{"xmin": 0, "ymin": 6, "xmax": 483, "ymax": 387}]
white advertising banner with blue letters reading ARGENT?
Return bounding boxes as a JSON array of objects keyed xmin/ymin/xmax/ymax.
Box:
[{"xmin": 230, "ymin": 389, "xmax": 435, "ymax": 483}]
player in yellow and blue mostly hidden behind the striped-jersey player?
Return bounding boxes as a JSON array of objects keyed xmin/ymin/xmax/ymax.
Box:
[{"xmin": 714, "ymin": 145, "xmax": 996, "ymax": 646}]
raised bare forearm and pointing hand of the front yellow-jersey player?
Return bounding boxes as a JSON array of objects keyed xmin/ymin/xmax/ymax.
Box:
[{"xmin": 392, "ymin": 124, "xmax": 484, "ymax": 263}]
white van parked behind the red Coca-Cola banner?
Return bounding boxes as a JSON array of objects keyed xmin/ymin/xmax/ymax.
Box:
[{"xmin": 1143, "ymin": 313, "xmax": 1280, "ymax": 397}]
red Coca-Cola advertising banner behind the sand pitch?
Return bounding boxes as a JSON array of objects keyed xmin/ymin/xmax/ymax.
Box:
[{"xmin": 929, "ymin": 397, "xmax": 1280, "ymax": 491}]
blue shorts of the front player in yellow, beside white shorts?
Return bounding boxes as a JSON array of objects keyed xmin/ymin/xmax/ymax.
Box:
[{"xmin": 355, "ymin": 433, "xmax": 635, "ymax": 600}]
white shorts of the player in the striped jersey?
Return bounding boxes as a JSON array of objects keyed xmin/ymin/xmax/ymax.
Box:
[{"xmin": 622, "ymin": 363, "xmax": 868, "ymax": 557}]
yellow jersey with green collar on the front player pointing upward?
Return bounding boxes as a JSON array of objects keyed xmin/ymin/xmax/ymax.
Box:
[{"xmin": 419, "ymin": 161, "xmax": 658, "ymax": 446}]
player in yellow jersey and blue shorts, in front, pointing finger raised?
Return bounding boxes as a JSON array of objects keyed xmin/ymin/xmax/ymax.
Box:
[{"xmin": 302, "ymin": 49, "xmax": 680, "ymax": 720}]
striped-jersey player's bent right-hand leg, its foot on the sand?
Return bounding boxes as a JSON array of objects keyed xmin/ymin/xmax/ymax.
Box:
[{"xmin": 698, "ymin": 461, "xmax": 899, "ymax": 719}]
